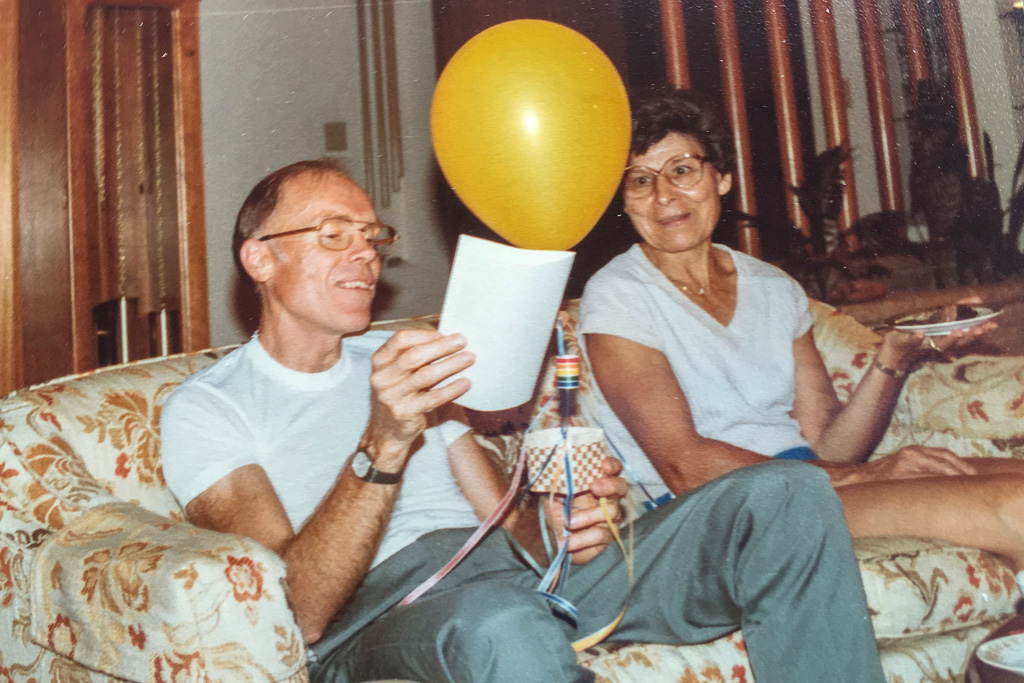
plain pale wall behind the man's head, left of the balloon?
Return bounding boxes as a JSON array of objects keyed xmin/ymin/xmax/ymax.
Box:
[{"xmin": 200, "ymin": 0, "xmax": 447, "ymax": 344}]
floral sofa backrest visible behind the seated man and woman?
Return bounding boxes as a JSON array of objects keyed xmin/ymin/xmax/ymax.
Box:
[{"xmin": 0, "ymin": 301, "xmax": 878, "ymax": 540}]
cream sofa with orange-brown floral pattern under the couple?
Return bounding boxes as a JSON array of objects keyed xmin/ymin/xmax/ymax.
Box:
[{"xmin": 0, "ymin": 302, "xmax": 1024, "ymax": 683}]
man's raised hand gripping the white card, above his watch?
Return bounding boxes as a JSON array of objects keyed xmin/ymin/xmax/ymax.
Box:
[{"xmin": 362, "ymin": 330, "xmax": 476, "ymax": 472}]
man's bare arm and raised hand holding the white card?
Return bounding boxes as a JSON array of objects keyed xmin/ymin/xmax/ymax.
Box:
[{"xmin": 185, "ymin": 330, "xmax": 473, "ymax": 642}]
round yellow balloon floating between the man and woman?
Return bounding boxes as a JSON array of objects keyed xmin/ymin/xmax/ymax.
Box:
[{"xmin": 430, "ymin": 19, "xmax": 630, "ymax": 250}]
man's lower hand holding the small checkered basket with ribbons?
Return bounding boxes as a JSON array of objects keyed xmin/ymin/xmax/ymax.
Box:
[{"xmin": 545, "ymin": 458, "xmax": 629, "ymax": 564}]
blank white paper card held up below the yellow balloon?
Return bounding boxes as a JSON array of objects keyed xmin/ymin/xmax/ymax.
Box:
[{"xmin": 438, "ymin": 234, "xmax": 575, "ymax": 411}]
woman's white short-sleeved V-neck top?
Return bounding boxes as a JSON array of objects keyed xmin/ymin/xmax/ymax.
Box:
[{"xmin": 579, "ymin": 245, "xmax": 811, "ymax": 497}]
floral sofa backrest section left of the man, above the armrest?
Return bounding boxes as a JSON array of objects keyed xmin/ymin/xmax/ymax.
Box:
[{"xmin": 0, "ymin": 347, "xmax": 231, "ymax": 529}]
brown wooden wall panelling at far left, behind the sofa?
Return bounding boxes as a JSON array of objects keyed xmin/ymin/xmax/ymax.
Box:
[{"xmin": 6, "ymin": 0, "xmax": 209, "ymax": 389}]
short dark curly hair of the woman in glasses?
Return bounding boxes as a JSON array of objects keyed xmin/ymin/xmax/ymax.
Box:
[{"xmin": 630, "ymin": 86, "xmax": 735, "ymax": 173}]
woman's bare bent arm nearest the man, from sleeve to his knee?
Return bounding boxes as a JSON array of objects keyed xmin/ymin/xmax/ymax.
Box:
[{"xmin": 587, "ymin": 334, "xmax": 770, "ymax": 494}]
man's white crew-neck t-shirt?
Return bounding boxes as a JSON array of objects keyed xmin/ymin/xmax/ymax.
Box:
[{"xmin": 161, "ymin": 332, "xmax": 479, "ymax": 565}]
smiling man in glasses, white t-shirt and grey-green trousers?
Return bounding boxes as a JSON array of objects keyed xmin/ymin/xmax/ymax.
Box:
[{"xmin": 162, "ymin": 161, "xmax": 883, "ymax": 683}]
